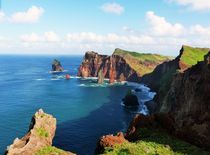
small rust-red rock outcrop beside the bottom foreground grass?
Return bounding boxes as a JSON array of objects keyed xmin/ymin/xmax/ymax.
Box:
[{"xmin": 95, "ymin": 132, "xmax": 128, "ymax": 154}]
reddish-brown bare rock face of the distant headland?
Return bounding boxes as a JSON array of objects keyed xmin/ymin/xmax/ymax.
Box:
[{"xmin": 78, "ymin": 52, "xmax": 139, "ymax": 82}]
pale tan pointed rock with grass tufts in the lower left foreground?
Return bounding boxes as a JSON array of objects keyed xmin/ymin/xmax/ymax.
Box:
[{"xmin": 6, "ymin": 110, "xmax": 73, "ymax": 155}]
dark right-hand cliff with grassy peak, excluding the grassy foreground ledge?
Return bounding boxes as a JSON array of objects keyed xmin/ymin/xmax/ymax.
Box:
[{"xmin": 142, "ymin": 47, "xmax": 210, "ymax": 148}]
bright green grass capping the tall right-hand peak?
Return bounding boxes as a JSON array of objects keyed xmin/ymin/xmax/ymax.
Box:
[{"xmin": 181, "ymin": 46, "xmax": 210, "ymax": 66}]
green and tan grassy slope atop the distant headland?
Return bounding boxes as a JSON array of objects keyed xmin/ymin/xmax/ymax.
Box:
[{"xmin": 113, "ymin": 49, "xmax": 170, "ymax": 76}]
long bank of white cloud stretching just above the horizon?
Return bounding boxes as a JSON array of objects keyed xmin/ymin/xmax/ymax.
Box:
[{"xmin": 0, "ymin": 11, "xmax": 210, "ymax": 56}]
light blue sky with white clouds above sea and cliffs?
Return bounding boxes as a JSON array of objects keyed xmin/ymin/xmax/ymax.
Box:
[{"xmin": 0, "ymin": 0, "xmax": 210, "ymax": 56}]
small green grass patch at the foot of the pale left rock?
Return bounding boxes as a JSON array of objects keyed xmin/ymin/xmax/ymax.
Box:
[{"xmin": 35, "ymin": 146, "xmax": 65, "ymax": 155}]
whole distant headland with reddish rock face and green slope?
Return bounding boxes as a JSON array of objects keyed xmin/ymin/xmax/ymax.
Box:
[{"xmin": 78, "ymin": 49, "xmax": 169, "ymax": 82}]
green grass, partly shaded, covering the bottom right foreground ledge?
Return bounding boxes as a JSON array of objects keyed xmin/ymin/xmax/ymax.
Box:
[{"xmin": 101, "ymin": 128, "xmax": 209, "ymax": 155}]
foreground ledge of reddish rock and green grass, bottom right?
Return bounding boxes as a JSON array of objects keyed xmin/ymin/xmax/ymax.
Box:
[{"xmin": 96, "ymin": 114, "xmax": 209, "ymax": 155}]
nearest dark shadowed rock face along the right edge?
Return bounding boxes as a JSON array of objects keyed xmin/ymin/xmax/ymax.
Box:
[{"xmin": 165, "ymin": 52, "xmax": 210, "ymax": 148}]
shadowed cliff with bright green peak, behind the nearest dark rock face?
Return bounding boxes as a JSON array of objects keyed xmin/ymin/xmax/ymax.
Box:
[{"xmin": 141, "ymin": 46, "xmax": 210, "ymax": 112}]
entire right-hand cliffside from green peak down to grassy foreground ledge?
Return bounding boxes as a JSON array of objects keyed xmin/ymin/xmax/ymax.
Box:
[{"xmin": 96, "ymin": 46, "xmax": 210, "ymax": 155}]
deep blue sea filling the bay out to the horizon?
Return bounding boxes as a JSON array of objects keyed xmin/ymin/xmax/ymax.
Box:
[{"xmin": 0, "ymin": 56, "xmax": 153, "ymax": 155}]
